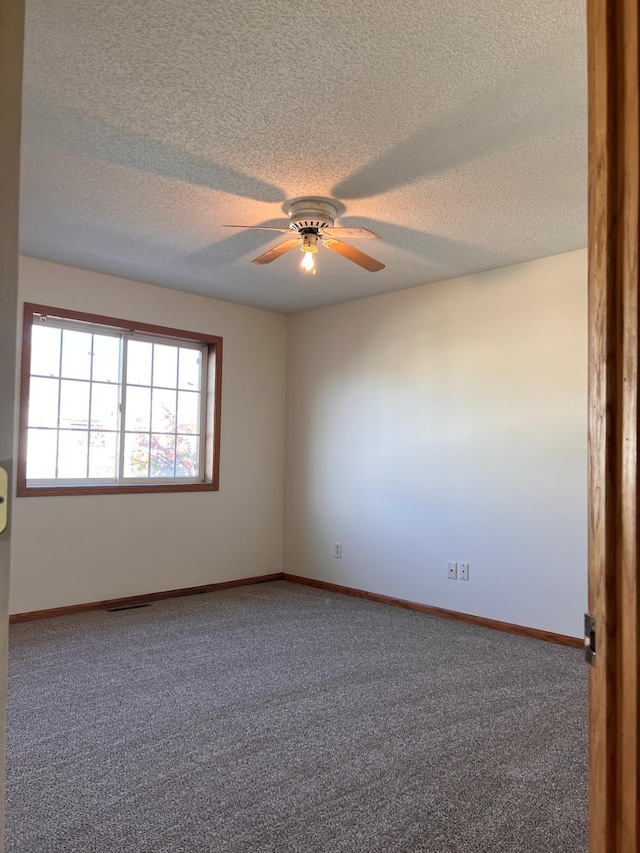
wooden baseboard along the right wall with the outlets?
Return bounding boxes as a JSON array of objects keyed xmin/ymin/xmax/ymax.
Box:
[{"xmin": 282, "ymin": 572, "xmax": 583, "ymax": 649}]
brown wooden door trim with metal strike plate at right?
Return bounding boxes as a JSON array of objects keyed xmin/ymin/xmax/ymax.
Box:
[{"xmin": 587, "ymin": 0, "xmax": 640, "ymax": 853}]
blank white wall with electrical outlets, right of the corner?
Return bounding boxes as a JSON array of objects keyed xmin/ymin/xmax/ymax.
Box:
[{"xmin": 285, "ymin": 251, "xmax": 587, "ymax": 636}]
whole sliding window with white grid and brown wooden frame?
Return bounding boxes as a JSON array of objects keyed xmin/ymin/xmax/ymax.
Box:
[{"xmin": 18, "ymin": 304, "xmax": 222, "ymax": 496}]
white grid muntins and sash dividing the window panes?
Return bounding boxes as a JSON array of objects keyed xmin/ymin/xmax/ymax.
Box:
[{"xmin": 26, "ymin": 314, "xmax": 208, "ymax": 488}]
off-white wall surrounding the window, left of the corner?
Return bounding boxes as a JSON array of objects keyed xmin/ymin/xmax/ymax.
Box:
[{"xmin": 10, "ymin": 258, "xmax": 286, "ymax": 613}]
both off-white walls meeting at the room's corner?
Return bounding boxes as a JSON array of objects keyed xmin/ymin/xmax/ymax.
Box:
[{"xmin": 10, "ymin": 251, "xmax": 587, "ymax": 636}]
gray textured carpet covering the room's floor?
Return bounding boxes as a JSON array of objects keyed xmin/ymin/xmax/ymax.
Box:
[{"xmin": 6, "ymin": 581, "xmax": 587, "ymax": 853}]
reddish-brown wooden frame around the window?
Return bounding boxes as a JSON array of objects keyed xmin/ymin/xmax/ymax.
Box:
[{"xmin": 16, "ymin": 302, "xmax": 222, "ymax": 498}]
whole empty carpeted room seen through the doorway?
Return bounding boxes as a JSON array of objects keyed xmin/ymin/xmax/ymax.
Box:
[{"xmin": 1, "ymin": 0, "xmax": 600, "ymax": 853}]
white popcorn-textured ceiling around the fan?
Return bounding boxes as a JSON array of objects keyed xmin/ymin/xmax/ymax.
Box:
[{"xmin": 21, "ymin": 0, "xmax": 586, "ymax": 312}]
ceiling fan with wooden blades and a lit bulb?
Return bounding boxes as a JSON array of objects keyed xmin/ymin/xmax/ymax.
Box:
[{"xmin": 224, "ymin": 197, "xmax": 384, "ymax": 275}]
